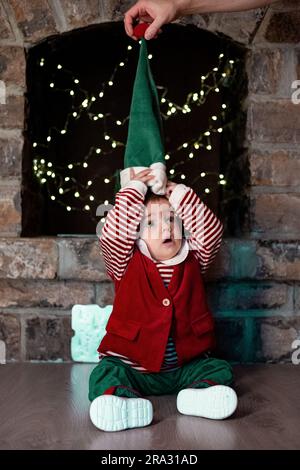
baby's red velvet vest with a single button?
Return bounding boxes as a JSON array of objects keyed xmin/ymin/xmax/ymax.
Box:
[{"xmin": 98, "ymin": 246, "xmax": 216, "ymax": 372}]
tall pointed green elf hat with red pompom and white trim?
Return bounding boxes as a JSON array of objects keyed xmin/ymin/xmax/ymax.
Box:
[{"xmin": 116, "ymin": 23, "xmax": 167, "ymax": 194}]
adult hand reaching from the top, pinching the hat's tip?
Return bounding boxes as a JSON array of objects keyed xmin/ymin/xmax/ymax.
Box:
[{"xmin": 124, "ymin": 0, "xmax": 180, "ymax": 40}]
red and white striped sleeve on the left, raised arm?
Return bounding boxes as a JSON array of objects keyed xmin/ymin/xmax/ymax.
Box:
[{"xmin": 99, "ymin": 180, "xmax": 147, "ymax": 280}]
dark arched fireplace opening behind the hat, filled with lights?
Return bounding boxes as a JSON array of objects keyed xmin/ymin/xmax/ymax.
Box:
[{"xmin": 22, "ymin": 22, "xmax": 249, "ymax": 237}]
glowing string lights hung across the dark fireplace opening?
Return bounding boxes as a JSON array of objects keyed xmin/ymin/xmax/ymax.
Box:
[{"xmin": 32, "ymin": 45, "xmax": 236, "ymax": 220}]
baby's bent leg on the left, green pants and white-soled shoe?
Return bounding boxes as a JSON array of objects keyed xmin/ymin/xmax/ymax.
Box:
[{"xmin": 89, "ymin": 357, "xmax": 153, "ymax": 431}]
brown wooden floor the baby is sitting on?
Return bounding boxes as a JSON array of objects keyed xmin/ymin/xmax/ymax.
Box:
[{"xmin": 0, "ymin": 363, "xmax": 300, "ymax": 450}]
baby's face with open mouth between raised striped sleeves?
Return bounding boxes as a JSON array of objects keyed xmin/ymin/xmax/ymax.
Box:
[{"xmin": 140, "ymin": 198, "xmax": 182, "ymax": 261}]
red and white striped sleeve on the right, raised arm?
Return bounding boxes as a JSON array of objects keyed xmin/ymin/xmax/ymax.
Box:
[{"xmin": 169, "ymin": 184, "xmax": 224, "ymax": 274}]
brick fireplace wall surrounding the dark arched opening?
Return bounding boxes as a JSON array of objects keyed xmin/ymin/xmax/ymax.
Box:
[{"xmin": 0, "ymin": 0, "xmax": 300, "ymax": 362}]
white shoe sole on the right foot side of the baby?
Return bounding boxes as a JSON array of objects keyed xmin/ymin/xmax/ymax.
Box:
[{"xmin": 177, "ymin": 385, "xmax": 238, "ymax": 419}]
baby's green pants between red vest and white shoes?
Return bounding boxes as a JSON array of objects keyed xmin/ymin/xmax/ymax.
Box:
[{"xmin": 89, "ymin": 356, "xmax": 233, "ymax": 401}]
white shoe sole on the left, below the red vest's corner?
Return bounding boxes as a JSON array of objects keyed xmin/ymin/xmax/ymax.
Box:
[{"xmin": 90, "ymin": 395, "xmax": 153, "ymax": 431}]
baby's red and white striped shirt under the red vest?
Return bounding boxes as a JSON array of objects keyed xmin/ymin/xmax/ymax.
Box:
[{"xmin": 99, "ymin": 181, "xmax": 223, "ymax": 373}]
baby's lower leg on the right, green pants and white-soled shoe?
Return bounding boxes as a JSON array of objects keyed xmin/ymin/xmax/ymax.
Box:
[{"xmin": 177, "ymin": 358, "xmax": 237, "ymax": 419}]
